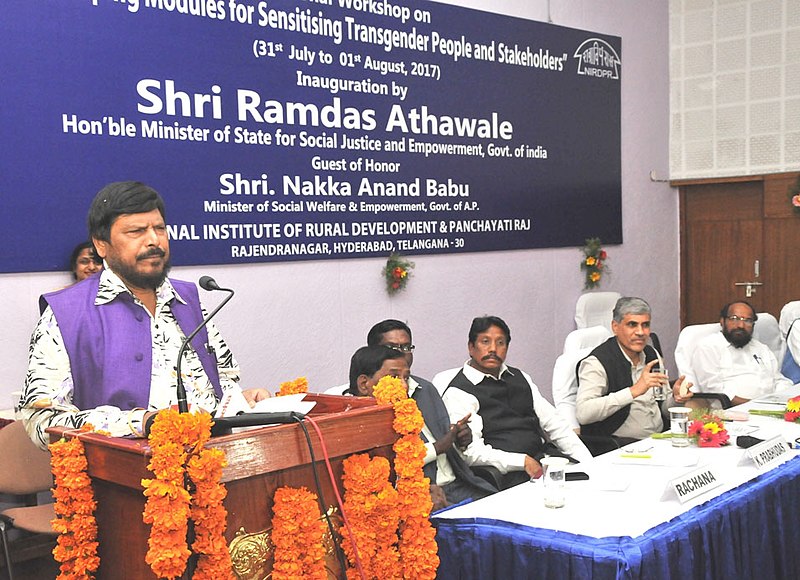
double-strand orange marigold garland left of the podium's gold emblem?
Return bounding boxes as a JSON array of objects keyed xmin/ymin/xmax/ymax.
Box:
[{"xmin": 142, "ymin": 409, "xmax": 232, "ymax": 579}]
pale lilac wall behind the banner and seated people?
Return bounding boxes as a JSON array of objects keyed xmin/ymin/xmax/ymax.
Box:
[{"xmin": 0, "ymin": 0, "xmax": 679, "ymax": 408}]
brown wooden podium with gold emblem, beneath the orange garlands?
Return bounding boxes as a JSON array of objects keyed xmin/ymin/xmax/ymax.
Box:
[{"xmin": 48, "ymin": 393, "xmax": 397, "ymax": 580}]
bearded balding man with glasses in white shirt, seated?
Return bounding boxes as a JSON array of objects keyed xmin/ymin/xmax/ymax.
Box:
[{"xmin": 691, "ymin": 301, "xmax": 792, "ymax": 405}]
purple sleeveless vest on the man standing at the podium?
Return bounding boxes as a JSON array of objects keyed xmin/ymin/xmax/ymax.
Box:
[{"xmin": 39, "ymin": 275, "xmax": 222, "ymax": 410}]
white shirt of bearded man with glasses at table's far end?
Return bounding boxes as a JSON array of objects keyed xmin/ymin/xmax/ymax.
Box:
[{"xmin": 691, "ymin": 330, "xmax": 792, "ymax": 399}]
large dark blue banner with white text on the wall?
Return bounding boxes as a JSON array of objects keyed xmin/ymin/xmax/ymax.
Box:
[{"xmin": 0, "ymin": 0, "xmax": 622, "ymax": 272}]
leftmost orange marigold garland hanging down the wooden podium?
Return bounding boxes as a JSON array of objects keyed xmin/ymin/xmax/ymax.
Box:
[{"xmin": 49, "ymin": 424, "xmax": 100, "ymax": 580}]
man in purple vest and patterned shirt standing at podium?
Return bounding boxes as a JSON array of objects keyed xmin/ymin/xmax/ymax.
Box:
[{"xmin": 20, "ymin": 181, "xmax": 268, "ymax": 446}]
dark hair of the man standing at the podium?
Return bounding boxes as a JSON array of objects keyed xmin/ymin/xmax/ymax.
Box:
[{"xmin": 86, "ymin": 181, "xmax": 167, "ymax": 242}]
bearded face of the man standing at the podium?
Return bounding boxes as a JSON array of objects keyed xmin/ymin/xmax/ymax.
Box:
[{"xmin": 93, "ymin": 209, "xmax": 169, "ymax": 289}]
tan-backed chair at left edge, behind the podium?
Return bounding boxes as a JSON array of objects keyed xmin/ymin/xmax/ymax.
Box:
[{"xmin": 0, "ymin": 421, "xmax": 56, "ymax": 579}]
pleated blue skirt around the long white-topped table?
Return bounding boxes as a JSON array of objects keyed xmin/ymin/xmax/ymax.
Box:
[{"xmin": 433, "ymin": 457, "xmax": 800, "ymax": 580}]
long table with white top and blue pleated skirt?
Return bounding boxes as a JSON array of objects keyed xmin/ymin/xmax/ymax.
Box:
[{"xmin": 433, "ymin": 396, "xmax": 800, "ymax": 580}]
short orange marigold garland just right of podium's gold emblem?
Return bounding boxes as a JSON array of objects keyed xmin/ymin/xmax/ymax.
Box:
[{"xmin": 272, "ymin": 487, "xmax": 328, "ymax": 580}]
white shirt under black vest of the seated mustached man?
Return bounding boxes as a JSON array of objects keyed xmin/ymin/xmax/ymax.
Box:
[{"xmin": 432, "ymin": 361, "xmax": 592, "ymax": 473}]
